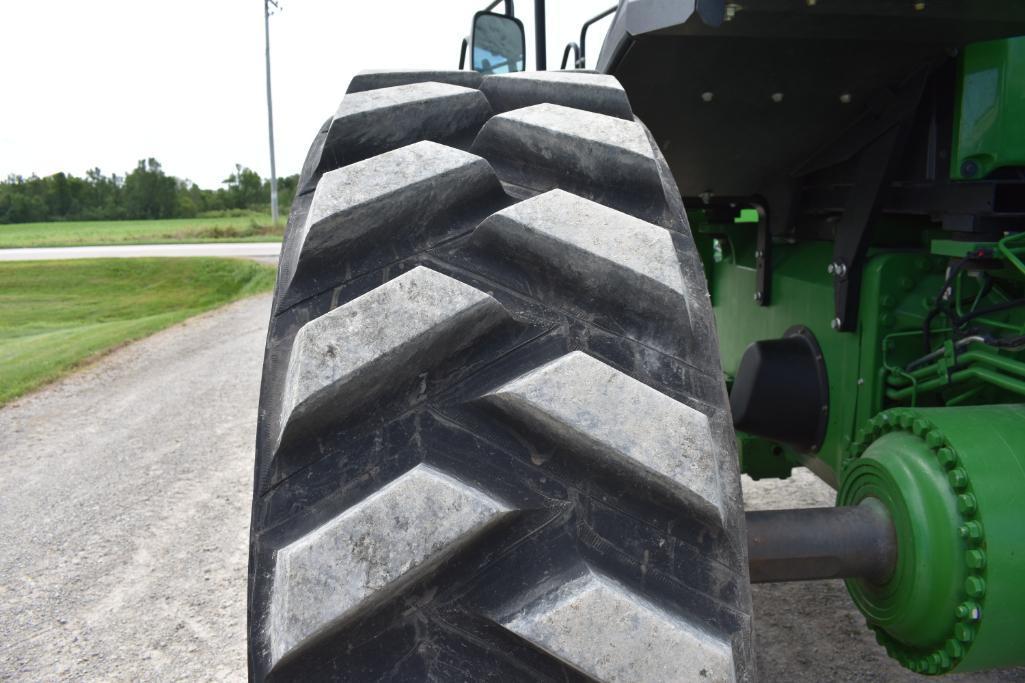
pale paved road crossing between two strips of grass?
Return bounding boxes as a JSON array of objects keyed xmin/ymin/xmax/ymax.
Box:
[{"xmin": 0, "ymin": 242, "xmax": 281, "ymax": 260}]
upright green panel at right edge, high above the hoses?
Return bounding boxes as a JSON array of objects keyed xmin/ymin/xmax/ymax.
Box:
[{"xmin": 950, "ymin": 37, "xmax": 1025, "ymax": 179}]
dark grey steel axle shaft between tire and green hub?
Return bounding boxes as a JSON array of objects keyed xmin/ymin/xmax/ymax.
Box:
[{"xmin": 747, "ymin": 498, "xmax": 897, "ymax": 584}]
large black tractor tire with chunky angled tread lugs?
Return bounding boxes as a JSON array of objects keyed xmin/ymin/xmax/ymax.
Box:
[{"xmin": 249, "ymin": 72, "xmax": 753, "ymax": 682}]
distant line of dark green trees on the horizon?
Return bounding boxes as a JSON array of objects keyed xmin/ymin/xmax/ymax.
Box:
[{"xmin": 0, "ymin": 159, "xmax": 299, "ymax": 224}]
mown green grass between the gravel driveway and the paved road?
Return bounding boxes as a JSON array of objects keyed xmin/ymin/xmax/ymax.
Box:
[{"xmin": 0, "ymin": 258, "xmax": 274, "ymax": 405}]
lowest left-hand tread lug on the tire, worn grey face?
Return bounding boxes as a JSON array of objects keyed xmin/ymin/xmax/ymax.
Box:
[{"xmin": 268, "ymin": 465, "xmax": 510, "ymax": 668}]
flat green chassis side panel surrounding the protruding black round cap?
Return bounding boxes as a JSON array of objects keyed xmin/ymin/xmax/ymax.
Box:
[{"xmin": 692, "ymin": 216, "xmax": 945, "ymax": 477}]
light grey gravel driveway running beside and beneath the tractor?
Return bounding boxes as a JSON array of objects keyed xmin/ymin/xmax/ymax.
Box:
[{"xmin": 0, "ymin": 295, "xmax": 1025, "ymax": 683}]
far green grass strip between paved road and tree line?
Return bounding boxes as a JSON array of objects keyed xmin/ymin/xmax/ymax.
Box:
[{"xmin": 0, "ymin": 213, "xmax": 284, "ymax": 248}]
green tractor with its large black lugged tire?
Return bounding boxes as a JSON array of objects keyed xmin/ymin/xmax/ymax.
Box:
[{"xmin": 248, "ymin": 0, "xmax": 1025, "ymax": 682}]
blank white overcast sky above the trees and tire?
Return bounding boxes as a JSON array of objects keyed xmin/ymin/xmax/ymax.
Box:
[{"xmin": 0, "ymin": 0, "xmax": 615, "ymax": 188}]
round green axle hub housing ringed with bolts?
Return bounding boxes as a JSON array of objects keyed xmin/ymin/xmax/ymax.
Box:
[{"xmin": 836, "ymin": 405, "xmax": 1025, "ymax": 674}]
